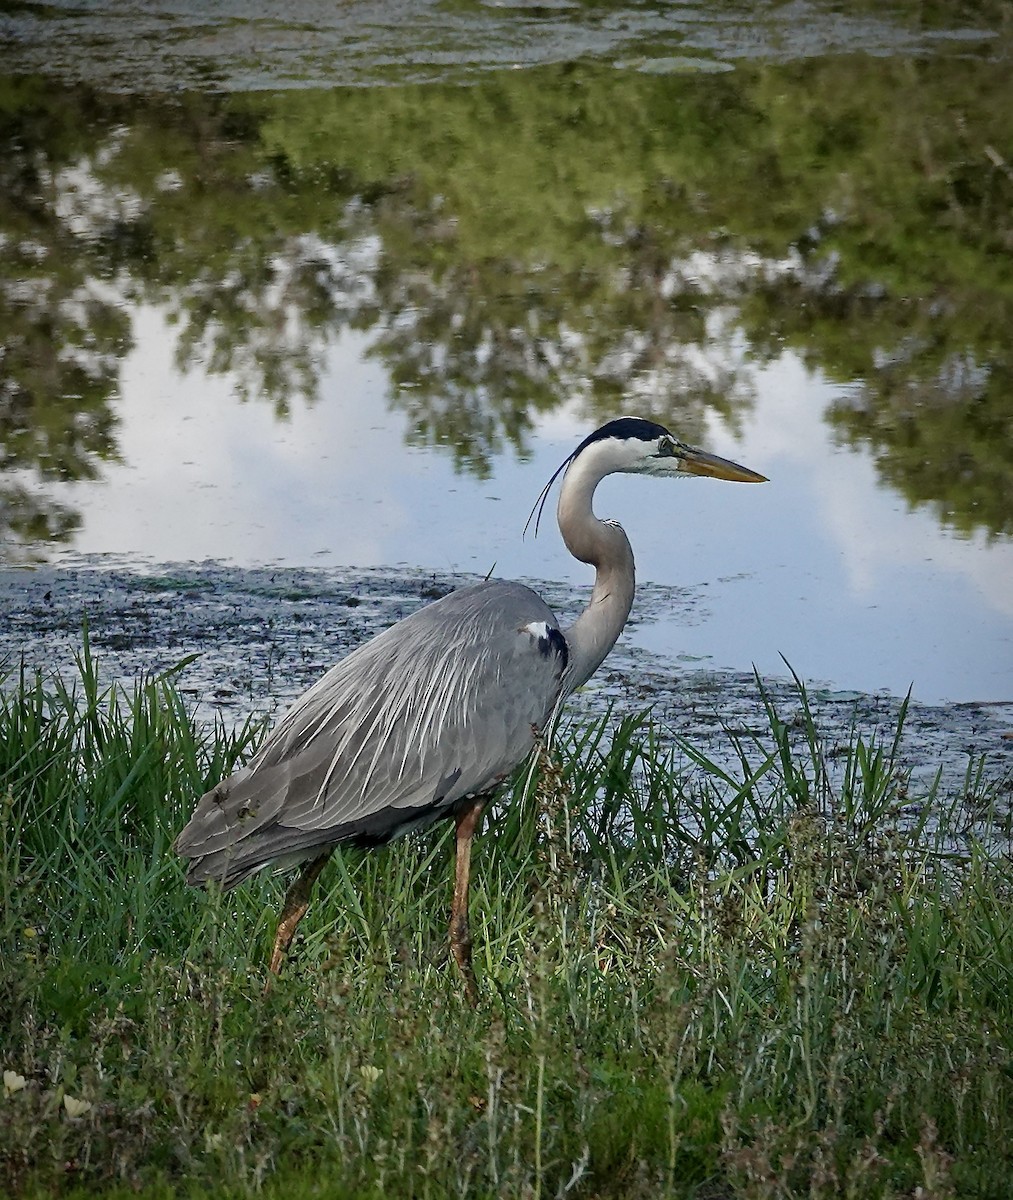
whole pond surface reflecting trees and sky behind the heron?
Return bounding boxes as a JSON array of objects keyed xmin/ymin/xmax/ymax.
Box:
[{"xmin": 0, "ymin": 4, "xmax": 1013, "ymax": 703}]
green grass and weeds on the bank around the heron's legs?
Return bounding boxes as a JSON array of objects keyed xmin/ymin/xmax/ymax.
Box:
[{"xmin": 0, "ymin": 643, "xmax": 1013, "ymax": 1200}]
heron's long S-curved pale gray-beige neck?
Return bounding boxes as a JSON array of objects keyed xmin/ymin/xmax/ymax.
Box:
[{"xmin": 557, "ymin": 454, "xmax": 635, "ymax": 692}]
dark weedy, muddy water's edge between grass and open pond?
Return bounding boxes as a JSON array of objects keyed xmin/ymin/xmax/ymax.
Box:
[{"xmin": 0, "ymin": 557, "xmax": 1013, "ymax": 809}]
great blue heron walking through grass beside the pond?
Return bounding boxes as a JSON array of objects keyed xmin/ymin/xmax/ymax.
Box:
[{"xmin": 175, "ymin": 416, "xmax": 765, "ymax": 996}]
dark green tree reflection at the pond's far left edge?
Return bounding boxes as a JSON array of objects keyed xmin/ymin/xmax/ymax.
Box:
[{"xmin": 0, "ymin": 82, "xmax": 130, "ymax": 557}]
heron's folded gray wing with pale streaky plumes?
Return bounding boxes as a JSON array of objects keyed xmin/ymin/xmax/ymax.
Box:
[{"xmin": 175, "ymin": 581, "xmax": 568, "ymax": 887}]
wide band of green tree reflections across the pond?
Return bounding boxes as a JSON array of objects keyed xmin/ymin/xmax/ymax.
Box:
[{"xmin": 0, "ymin": 42, "xmax": 1013, "ymax": 548}]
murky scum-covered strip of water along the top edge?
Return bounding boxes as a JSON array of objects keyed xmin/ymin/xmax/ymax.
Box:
[{"xmin": 0, "ymin": 0, "xmax": 1003, "ymax": 92}]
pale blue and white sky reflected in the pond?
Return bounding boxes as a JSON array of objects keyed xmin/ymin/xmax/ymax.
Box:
[{"xmin": 56, "ymin": 307, "xmax": 1013, "ymax": 702}]
